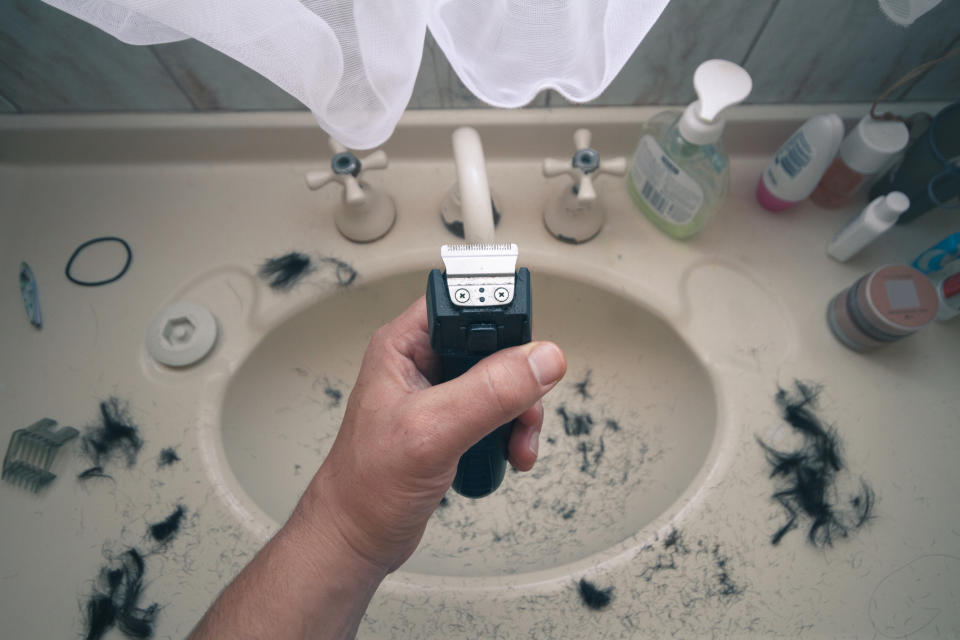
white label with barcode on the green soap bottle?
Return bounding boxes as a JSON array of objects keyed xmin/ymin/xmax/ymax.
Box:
[{"xmin": 631, "ymin": 135, "xmax": 703, "ymax": 225}]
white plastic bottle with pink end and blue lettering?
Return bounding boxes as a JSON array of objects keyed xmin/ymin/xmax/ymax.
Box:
[{"xmin": 757, "ymin": 113, "xmax": 843, "ymax": 211}]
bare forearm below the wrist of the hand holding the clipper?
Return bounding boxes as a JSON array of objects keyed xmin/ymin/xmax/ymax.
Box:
[{"xmin": 190, "ymin": 482, "xmax": 385, "ymax": 640}]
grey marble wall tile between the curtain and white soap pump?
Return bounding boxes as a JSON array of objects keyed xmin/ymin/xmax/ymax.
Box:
[{"xmin": 584, "ymin": 0, "xmax": 776, "ymax": 105}]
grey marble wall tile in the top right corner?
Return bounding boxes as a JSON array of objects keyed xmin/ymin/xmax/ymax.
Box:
[{"xmin": 745, "ymin": 0, "xmax": 960, "ymax": 103}]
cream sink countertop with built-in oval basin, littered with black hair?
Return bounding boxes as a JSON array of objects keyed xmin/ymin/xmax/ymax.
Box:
[{"xmin": 0, "ymin": 105, "xmax": 960, "ymax": 638}]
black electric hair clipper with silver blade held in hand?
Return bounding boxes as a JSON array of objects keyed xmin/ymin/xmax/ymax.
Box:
[{"xmin": 427, "ymin": 244, "xmax": 531, "ymax": 498}]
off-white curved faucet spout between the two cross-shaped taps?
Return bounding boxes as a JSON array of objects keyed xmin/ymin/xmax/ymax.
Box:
[{"xmin": 453, "ymin": 127, "xmax": 494, "ymax": 244}]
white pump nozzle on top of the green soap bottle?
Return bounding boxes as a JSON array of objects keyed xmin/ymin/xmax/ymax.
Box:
[{"xmin": 679, "ymin": 59, "xmax": 753, "ymax": 146}]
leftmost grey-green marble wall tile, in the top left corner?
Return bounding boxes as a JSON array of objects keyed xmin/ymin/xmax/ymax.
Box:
[{"xmin": 0, "ymin": 0, "xmax": 191, "ymax": 112}]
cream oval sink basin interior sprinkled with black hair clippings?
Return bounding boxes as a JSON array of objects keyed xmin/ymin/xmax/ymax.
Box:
[{"xmin": 221, "ymin": 270, "xmax": 716, "ymax": 577}]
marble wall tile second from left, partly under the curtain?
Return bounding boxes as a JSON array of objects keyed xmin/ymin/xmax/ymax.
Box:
[{"xmin": 151, "ymin": 40, "xmax": 306, "ymax": 111}]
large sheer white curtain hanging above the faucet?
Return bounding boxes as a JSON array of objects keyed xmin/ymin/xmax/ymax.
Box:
[{"xmin": 44, "ymin": 0, "xmax": 669, "ymax": 149}]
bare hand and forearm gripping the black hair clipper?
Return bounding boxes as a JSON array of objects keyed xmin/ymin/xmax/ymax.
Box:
[{"xmin": 191, "ymin": 298, "xmax": 566, "ymax": 640}]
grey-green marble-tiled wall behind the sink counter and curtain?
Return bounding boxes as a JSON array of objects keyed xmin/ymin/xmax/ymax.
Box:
[{"xmin": 0, "ymin": 0, "xmax": 960, "ymax": 113}]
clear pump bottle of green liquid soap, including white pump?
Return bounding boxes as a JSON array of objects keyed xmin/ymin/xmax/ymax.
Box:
[{"xmin": 627, "ymin": 60, "xmax": 753, "ymax": 240}]
